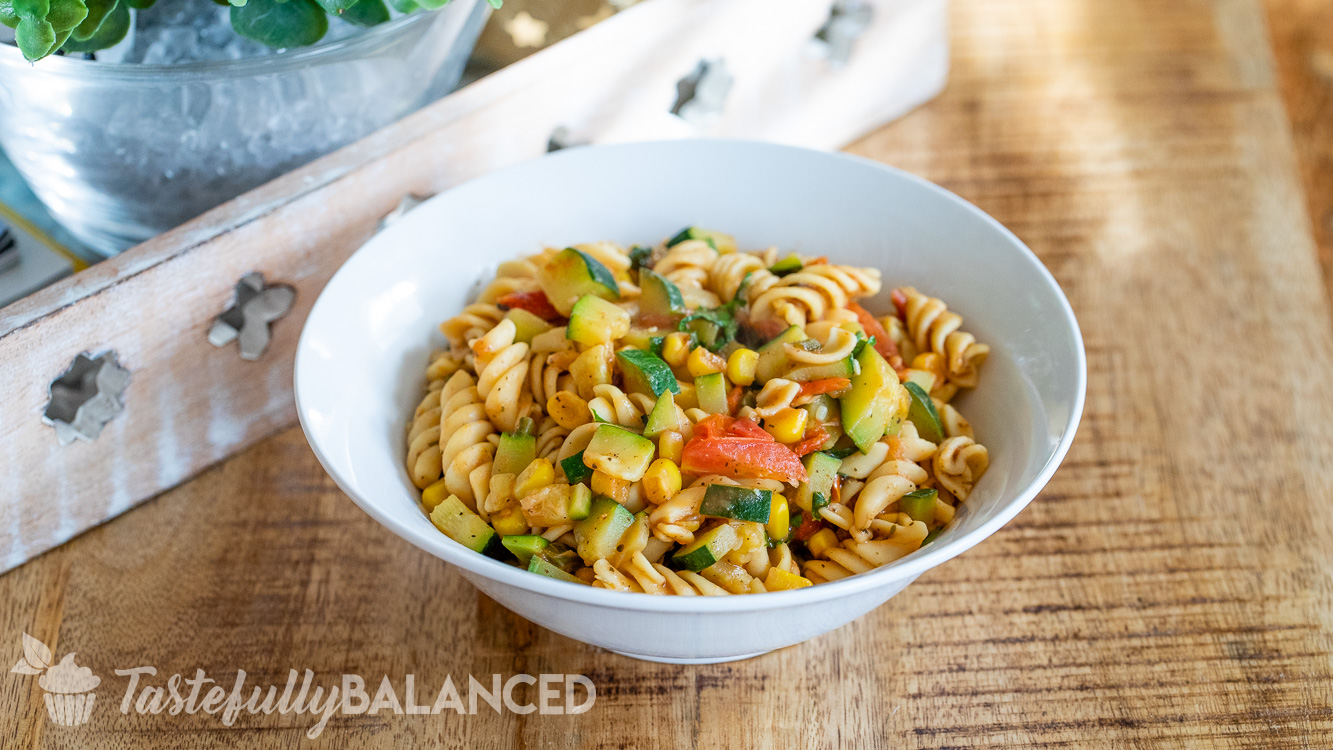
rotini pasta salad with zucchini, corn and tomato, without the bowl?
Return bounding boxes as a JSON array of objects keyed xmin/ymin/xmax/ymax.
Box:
[{"xmin": 405, "ymin": 226, "xmax": 990, "ymax": 595}]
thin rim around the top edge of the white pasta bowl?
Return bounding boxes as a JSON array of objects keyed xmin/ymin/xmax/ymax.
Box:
[{"xmin": 293, "ymin": 139, "xmax": 1088, "ymax": 614}]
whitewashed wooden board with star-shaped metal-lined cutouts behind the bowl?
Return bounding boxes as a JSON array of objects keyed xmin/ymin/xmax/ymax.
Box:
[{"xmin": 0, "ymin": 0, "xmax": 948, "ymax": 570}]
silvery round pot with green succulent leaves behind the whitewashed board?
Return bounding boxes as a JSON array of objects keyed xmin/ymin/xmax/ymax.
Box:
[{"xmin": 0, "ymin": 0, "xmax": 499, "ymax": 253}]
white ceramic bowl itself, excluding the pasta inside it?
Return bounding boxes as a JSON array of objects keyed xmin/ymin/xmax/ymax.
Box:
[{"xmin": 296, "ymin": 140, "xmax": 1086, "ymax": 663}]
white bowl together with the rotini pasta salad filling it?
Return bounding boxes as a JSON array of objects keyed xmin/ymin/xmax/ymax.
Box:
[{"xmin": 296, "ymin": 141, "xmax": 1085, "ymax": 662}]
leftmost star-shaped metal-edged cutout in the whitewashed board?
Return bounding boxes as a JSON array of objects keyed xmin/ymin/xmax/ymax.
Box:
[{"xmin": 41, "ymin": 352, "xmax": 129, "ymax": 445}]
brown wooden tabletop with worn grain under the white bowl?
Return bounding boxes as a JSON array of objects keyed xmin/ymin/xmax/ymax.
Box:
[{"xmin": 0, "ymin": 0, "xmax": 1333, "ymax": 749}]
